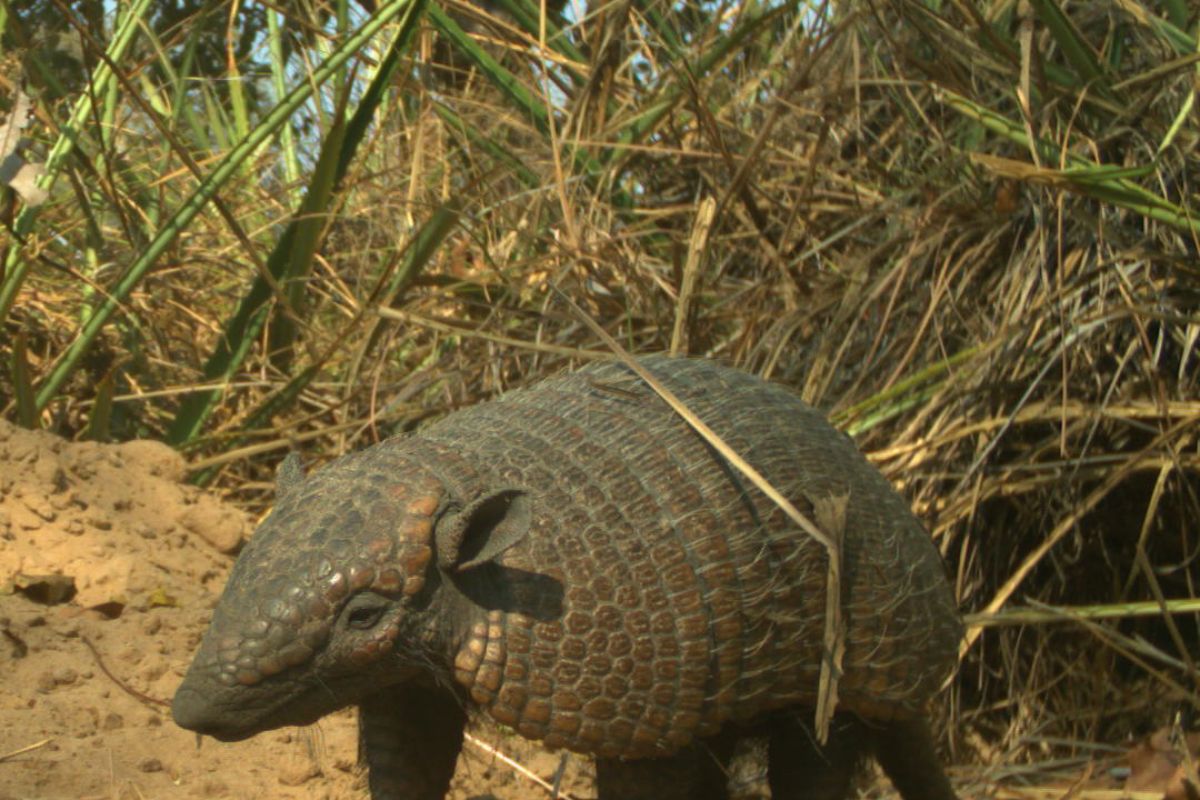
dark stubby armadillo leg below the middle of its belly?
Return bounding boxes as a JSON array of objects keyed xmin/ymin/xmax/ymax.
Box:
[{"xmin": 596, "ymin": 730, "xmax": 737, "ymax": 800}]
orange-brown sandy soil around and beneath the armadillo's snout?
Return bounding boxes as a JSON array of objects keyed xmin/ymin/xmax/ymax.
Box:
[{"xmin": 0, "ymin": 420, "xmax": 594, "ymax": 800}]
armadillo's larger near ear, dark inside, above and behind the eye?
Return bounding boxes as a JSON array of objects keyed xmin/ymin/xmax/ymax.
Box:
[{"xmin": 433, "ymin": 489, "xmax": 533, "ymax": 572}]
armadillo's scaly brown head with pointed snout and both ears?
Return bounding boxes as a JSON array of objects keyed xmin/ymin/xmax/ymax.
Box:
[{"xmin": 172, "ymin": 445, "xmax": 529, "ymax": 741}]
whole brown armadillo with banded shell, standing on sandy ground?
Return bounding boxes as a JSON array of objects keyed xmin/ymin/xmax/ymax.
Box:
[{"xmin": 173, "ymin": 357, "xmax": 960, "ymax": 800}]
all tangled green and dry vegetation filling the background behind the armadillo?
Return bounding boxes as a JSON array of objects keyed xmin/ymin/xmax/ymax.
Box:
[{"xmin": 0, "ymin": 0, "xmax": 1200, "ymax": 782}]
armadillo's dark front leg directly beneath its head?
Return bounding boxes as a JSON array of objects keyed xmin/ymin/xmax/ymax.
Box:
[{"xmin": 359, "ymin": 686, "xmax": 467, "ymax": 800}]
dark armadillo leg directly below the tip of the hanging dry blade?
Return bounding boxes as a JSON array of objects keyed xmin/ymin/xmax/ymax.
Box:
[{"xmin": 767, "ymin": 712, "xmax": 870, "ymax": 800}]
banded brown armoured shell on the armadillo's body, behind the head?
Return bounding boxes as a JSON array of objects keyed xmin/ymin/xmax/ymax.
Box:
[{"xmin": 406, "ymin": 357, "xmax": 960, "ymax": 757}]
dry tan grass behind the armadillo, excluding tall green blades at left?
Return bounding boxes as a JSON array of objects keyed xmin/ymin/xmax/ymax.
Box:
[{"xmin": 6, "ymin": 0, "xmax": 1200, "ymax": 783}]
